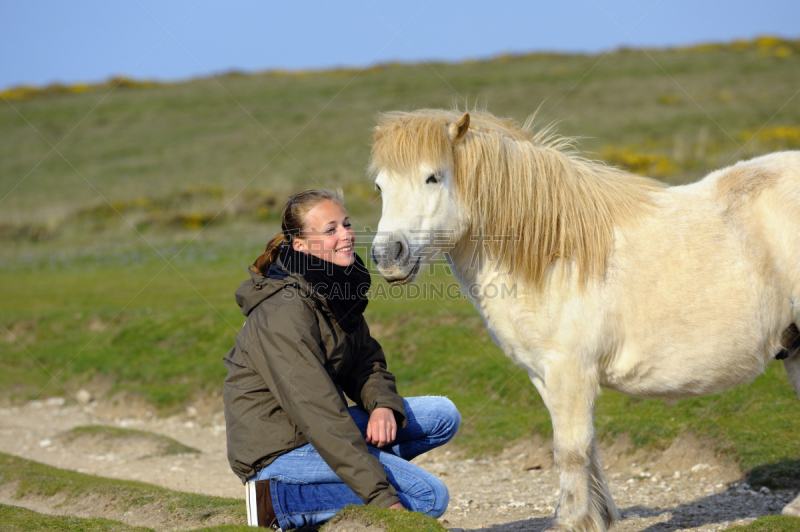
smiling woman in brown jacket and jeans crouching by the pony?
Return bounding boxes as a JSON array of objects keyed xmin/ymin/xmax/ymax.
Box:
[{"xmin": 223, "ymin": 190, "xmax": 461, "ymax": 530}]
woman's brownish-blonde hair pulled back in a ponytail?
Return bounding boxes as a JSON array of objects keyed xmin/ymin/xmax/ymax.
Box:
[{"xmin": 250, "ymin": 189, "xmax": 344, "ymax": 277}]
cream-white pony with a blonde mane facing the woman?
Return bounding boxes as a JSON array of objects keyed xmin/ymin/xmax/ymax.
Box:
[{"xmin": 370, "ymin": 110, "xmax": 800, "ymax": 532}]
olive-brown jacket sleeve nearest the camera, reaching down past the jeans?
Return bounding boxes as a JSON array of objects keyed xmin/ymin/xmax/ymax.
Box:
[{"xmin": 248, "ymin": 296, "xmax": 399, "ymax": 507}]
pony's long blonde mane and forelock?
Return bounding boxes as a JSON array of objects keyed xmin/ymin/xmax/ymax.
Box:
[{"xmin": 370, "ymin": 109, "xmax": 663, "ymax": 287}]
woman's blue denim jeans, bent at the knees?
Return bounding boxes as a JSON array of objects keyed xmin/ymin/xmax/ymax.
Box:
[{"xmin": 250, "ymin": 397, "xmax": 461, "ymax": 530}]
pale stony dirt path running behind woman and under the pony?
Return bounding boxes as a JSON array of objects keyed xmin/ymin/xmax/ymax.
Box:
[{"xmin": 0, "ymin": 398, "xmax": 797, "ymax": 532}]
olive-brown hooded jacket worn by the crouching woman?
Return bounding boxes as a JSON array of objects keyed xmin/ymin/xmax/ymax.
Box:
[{"xmin": 223, "ymin": 261, "xmax": 405, "ymax": 507}]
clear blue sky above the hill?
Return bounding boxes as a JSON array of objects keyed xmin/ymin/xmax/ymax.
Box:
[{"xmin": 0, "ymin": 0, "xmax": 800, "ymax": 88}]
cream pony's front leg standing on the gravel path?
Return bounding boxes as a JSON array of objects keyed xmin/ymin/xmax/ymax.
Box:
[{"xmin": 532, "ymin": 359, "xmax": 619, "ymax": 532}]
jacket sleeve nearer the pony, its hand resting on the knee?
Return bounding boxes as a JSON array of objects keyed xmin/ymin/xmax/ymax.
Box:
[{"xmin": 346, "ymin": 317, "xmax": 406, "ymax": 428}]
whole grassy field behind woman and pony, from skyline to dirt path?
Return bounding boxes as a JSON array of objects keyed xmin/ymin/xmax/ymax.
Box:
[{"xmin": 0, "ymin": 38, "xmax": 800, "ymax": 510}]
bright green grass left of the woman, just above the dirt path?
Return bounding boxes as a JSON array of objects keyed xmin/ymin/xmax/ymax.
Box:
[{"xmin": 0, "ymin": 265, "xmax": 244, "ymax": 406}]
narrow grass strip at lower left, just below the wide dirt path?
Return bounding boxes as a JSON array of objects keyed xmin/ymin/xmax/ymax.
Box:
[{"xmin": 0, "ymin": 453, "xmax": 246, "ymax": 523}]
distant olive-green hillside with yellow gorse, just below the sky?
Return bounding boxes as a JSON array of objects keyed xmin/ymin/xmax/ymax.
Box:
[{"xmin": 0, "ymin": 38, "xmax": 800, "ymax": 243}]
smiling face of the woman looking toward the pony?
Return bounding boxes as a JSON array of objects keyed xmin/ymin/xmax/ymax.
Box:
[{"xmin": 292, "ymin": 201, "xmax": 356, "ymax": 266}]
